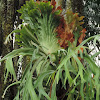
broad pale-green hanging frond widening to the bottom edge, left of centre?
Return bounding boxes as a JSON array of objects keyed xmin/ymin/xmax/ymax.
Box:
[{"xmin": 19, "ymin": 69, "xmax": 39, "ymax": 100}]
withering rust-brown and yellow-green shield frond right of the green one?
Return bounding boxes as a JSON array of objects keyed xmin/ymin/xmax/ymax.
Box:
[{"xmin": 56, "ymin": 10, "xmax": 86, "ymax": 48}]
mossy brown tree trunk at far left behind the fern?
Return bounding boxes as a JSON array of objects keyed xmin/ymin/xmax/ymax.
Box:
[{"xmin": 0, "ymin": 0, "xmax": 15, "ymax": 100}]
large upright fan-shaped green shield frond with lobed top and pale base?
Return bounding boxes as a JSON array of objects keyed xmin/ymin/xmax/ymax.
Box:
[{"xmin": 18, "ymin": 1, "xmax": 60, "ymax": 54}]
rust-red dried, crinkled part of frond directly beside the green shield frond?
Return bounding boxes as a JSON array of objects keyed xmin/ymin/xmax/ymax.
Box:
[{"xmin": 56, "ymin": 16, "xmax": 74, "ymax": 48}]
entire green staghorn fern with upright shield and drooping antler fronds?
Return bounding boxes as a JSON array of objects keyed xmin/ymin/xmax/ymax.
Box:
[{"xmin": 0, "ymin": 0, "xmax": 100, "ymax": 100}]
